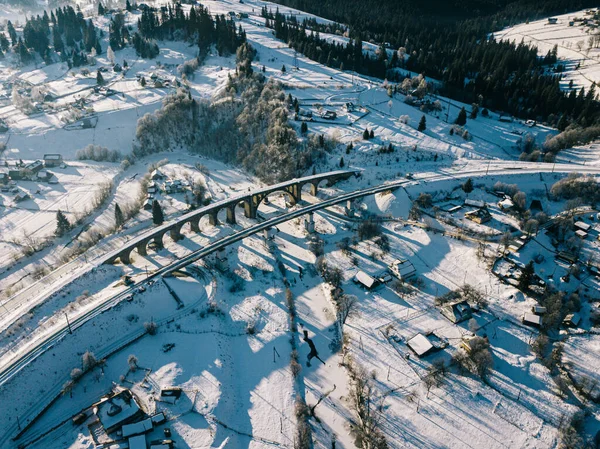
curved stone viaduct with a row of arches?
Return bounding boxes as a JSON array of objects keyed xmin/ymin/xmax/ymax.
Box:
[{"xmin": 104, "ymin": 170, "xmax": 360, "ymax": 264}]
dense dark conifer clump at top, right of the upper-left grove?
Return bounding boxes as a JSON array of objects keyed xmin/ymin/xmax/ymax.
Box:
[{"xmin": 138, "ymin": 3, "xmax": 246, "ymax": 56}]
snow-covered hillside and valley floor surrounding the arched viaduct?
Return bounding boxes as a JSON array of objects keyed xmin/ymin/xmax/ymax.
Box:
[{"xmin": 0, "ymin": 0, "xmax": 599, "ymax": 449}]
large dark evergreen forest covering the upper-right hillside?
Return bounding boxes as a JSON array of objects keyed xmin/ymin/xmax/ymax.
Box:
[{"xmin": 263, "ymin": 0, "xmax": 598, "ymax": 126}]
